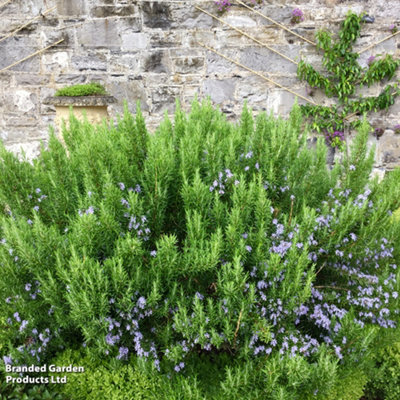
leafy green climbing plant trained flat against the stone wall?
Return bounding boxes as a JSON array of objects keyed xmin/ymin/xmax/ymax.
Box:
[{"xmin": 297, "ymin": 12, "xmax": 400, "ymax": 148}]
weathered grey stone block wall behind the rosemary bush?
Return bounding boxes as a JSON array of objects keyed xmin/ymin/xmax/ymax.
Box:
[{"xmin": 0, "ymin": 0, "xmax": 400, "ymax": 170}]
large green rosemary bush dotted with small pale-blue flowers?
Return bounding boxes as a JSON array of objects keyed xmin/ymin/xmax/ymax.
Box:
[{"xmin": 0, "ymin": 102, "xmax": 400, "ymax": 399}]
